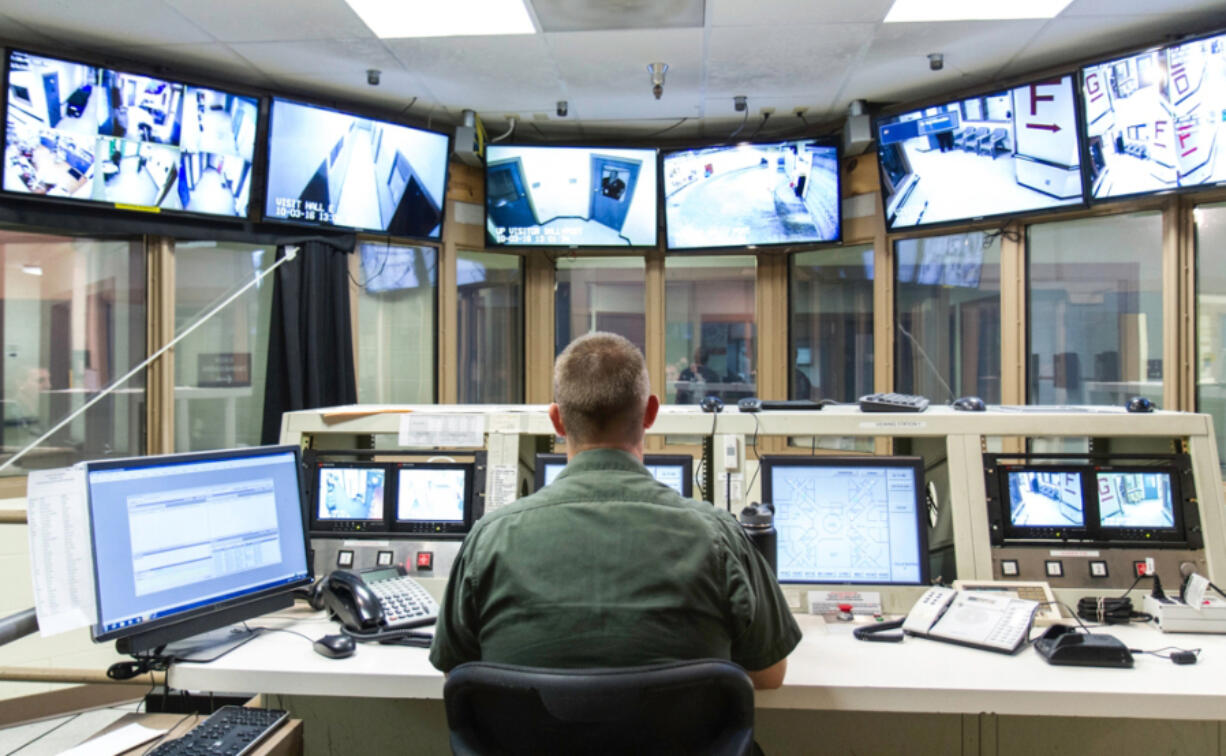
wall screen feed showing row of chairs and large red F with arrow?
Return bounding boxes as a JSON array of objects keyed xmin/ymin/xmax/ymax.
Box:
[{"xmin": 877, "ymin": 76, "xmax": 1083, "ymax": 229}]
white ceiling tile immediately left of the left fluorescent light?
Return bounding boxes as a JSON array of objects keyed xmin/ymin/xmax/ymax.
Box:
[{"xmin": 164, "ymin": 0, "xmax": 374, "ymax": 42}]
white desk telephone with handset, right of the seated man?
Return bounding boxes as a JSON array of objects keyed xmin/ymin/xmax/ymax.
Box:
[{"xmin": 855, "ymin": 587, "xmax": 1038, "ymax": 653}]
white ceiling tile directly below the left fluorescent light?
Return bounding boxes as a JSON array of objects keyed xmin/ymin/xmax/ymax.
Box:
[{"xmin": 384, "ymin": 34, "xmax": 565, "ymax": 113}]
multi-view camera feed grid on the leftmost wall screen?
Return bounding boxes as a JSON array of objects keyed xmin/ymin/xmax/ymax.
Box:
[{"xmin": 4, "ymin": 50, "xmax": 260, "ymax": 217}]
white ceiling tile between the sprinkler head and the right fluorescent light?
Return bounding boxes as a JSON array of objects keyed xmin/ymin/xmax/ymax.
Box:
[{"xmin": 706, "ymin": 23, "xmax": 874, "ymax": 102}]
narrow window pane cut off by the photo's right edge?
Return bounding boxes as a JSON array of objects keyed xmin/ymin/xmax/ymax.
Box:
[{"xmin": 1193, "ymin": 205, "xmax": 1226, "ymax": 477}]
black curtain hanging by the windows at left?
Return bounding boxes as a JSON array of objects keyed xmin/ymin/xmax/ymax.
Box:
[{"xmin": 261, "ymin": 240, "xmax": 358, "ymax": 444}]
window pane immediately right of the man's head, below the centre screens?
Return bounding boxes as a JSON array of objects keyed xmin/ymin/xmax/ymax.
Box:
[{"xmin": 664, "ymin": 257, "xmax": 758, "ymax": 404}]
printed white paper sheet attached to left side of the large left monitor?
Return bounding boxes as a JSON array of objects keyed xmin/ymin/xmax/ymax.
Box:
[{"xmin": 26, "ymin": 467, "xmax": 97, "ymax": 637}]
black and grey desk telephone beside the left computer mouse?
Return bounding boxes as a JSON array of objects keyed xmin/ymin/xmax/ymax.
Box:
[{"xmin": 322, "ymin": 566, "xmax": 439, "ymax": 633}]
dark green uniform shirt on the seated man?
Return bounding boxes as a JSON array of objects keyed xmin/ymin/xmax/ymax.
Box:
[{"xmin": 430, "ymin": 448, "xmax": 801, "ymax": 671}]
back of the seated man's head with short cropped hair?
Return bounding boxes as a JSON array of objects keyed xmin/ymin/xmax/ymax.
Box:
[{"xmin": 553, "ymin": 331, "xmax": 651, "ymax": 445}]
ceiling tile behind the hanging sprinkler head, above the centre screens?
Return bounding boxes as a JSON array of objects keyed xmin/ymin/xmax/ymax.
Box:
[{"xmin": 546, "ymin": 29, "xmax": 702, "ymax": 95}]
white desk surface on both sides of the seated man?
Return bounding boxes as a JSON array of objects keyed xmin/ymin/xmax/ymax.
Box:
[{"xmin": 170, "ymin": 609, "xmax": 1226, "ymax": 720}]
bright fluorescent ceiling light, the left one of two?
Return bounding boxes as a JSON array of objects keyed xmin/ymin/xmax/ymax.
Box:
[{"xmin": 345, "ymin": 0, "xmax": 536, "ymax": 39}]
